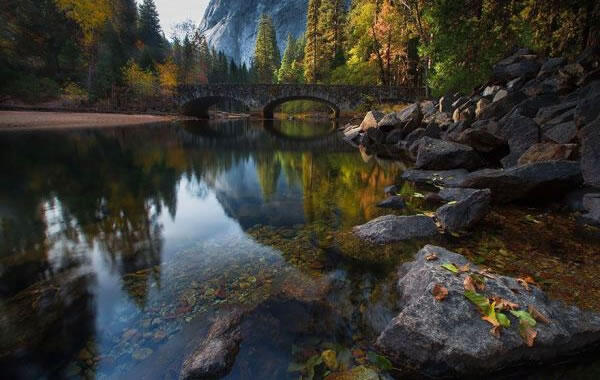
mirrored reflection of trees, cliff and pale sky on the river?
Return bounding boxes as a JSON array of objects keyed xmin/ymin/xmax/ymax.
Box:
[{"xmin": 0, "ymin": 121, "xmax": 398, "ymax": 378}]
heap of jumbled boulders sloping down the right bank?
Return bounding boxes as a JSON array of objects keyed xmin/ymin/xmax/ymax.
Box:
[{"xmin": 343, "ymin": 49, "xmax": 600, "ymax": 211}]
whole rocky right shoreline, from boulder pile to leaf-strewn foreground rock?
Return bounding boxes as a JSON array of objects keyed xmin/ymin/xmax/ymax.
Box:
[{"xmin": 343, "ymin": 49, "xmax": 600, "ymax": 377}]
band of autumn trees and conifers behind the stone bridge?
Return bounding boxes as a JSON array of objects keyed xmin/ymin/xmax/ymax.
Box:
[{"xmin": 0, "ymin": 0, "xmax": 600, "ymax": 104}]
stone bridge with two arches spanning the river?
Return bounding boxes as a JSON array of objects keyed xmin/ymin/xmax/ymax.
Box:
[{"xmin": 177, "ymin": 84, "xmax": 425, "ymax": 119}]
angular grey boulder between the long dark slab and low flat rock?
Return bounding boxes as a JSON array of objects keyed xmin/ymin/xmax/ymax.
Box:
[{"xmin": 435, "ymin": 189, "xmax": 492, "ymax": 232}]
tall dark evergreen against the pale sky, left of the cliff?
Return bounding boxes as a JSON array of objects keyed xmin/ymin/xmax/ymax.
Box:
[{"xmin": 138, "ymin": 0, "xmax": 165, "ymax": 69}]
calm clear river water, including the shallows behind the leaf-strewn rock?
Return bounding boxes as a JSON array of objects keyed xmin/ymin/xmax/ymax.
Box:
[{"xmin": 0, "ymin": 121, "xmax": 600, "ymax": 379}]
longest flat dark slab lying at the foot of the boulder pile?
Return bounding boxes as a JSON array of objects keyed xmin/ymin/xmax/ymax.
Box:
[{"xmin": 455, "ymin": 161, "xmax": 583, "ymax": 202}]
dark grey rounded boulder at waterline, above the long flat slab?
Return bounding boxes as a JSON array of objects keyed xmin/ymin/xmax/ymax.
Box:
[{"xmin": 415, "ymin": 137, "xmax": 483, "ymax": 170}]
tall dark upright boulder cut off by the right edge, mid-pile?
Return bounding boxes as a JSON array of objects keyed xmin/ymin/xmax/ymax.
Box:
[{"xmin": 579, "ymin": 116, "xmax": 600, "ymax": 187}]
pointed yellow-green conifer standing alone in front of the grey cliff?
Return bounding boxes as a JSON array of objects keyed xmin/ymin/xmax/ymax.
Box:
[{"xmin": 253, "ymin": 14, "xmax": 280, "ymax": 83}]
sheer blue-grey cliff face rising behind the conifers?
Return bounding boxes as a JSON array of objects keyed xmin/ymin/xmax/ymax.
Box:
[{"xmin": 200, "ymin": 0, "xmax": 308, "ymax": 64}]
